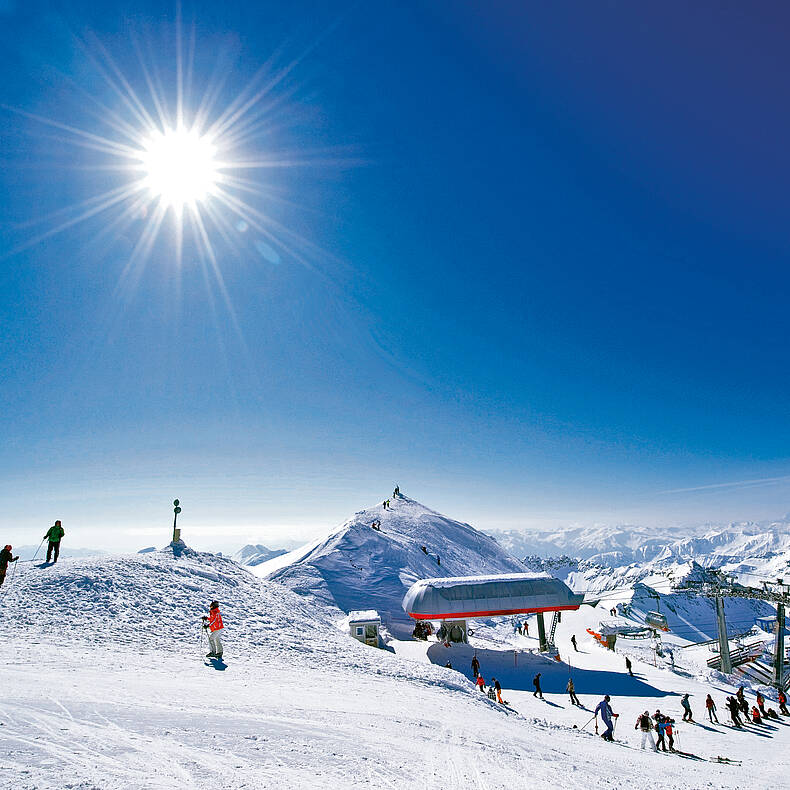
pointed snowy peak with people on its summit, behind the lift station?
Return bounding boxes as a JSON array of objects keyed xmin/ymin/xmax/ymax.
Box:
[{"xmin": 253, "ymin": 496, "xmax": 525, "ymax": 635}]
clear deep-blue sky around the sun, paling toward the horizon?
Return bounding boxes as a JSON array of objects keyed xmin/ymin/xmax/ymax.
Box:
[{"xmin": 0, "ymin": 0, "xmax": 790, "ymax": 549}]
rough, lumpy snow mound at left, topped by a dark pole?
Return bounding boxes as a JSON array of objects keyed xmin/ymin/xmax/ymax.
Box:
[{"xmin": 0, "ymin": 543, "xmax": 469, "ymax": 693}]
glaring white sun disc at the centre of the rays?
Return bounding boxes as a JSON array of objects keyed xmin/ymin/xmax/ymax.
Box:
[{"xmin": 140, "ymin": 126, "xmax": 218, "ymax": 212}]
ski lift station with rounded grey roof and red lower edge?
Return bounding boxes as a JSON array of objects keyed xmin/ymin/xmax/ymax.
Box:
[{"xmin": 403, "ymin": 573, "xmax": 584, "ymax": 642}]
